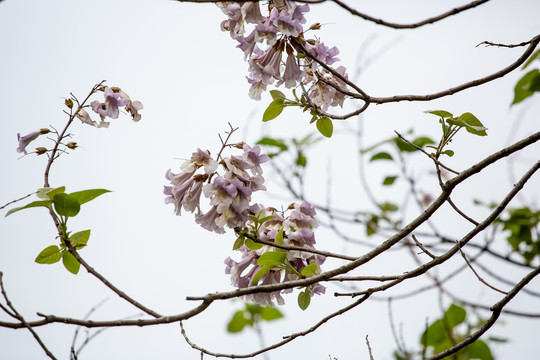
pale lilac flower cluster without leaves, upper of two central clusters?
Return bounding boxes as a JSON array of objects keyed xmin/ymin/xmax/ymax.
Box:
[{"xmin": 164, "ymin": 143, "xmax": 268, "ymax": 234}]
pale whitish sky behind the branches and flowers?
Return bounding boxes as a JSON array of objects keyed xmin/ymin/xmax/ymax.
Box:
[{"xmin": 0, "ymin": 0, "xmax": 540, "ymax": 360}]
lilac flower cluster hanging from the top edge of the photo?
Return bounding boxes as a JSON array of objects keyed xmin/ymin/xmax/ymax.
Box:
[{"xmin": 217, "ymin": 0, "xmax": 347, "ymax": 110}]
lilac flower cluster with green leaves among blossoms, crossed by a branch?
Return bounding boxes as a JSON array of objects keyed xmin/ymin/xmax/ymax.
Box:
[{"xmin": 225, "ymin": 201, "xmax": 326, "ymax": 307}]
